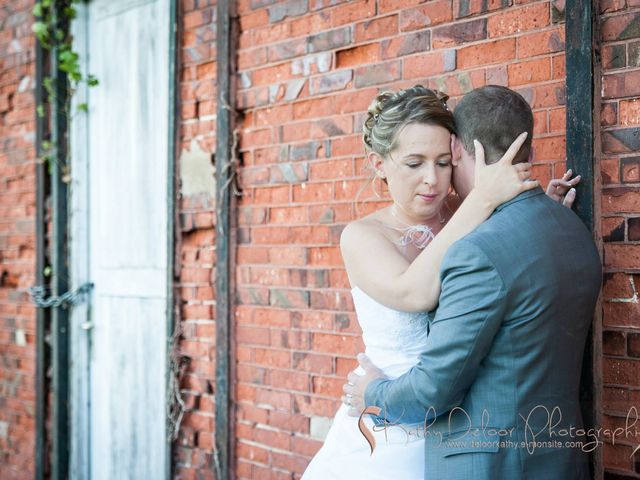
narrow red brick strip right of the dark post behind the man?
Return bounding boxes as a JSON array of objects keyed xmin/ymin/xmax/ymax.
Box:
[{"xmin": 599, "ymin": 0, "xmax": 640, "ymax": 478}]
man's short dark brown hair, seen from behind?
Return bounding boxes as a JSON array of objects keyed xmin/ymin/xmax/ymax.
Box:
[{"xmin": 453, "ymin": 85, "xmax": 533, "ymax": 164}]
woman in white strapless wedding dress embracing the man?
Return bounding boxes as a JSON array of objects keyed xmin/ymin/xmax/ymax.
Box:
[{"xmin": 302, "ymin": 85, "xmax": 579, "ymax": 480}]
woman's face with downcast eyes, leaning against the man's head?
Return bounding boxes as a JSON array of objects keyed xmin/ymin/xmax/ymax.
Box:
[{"xmin": 379, "ymin": 123, "xmax": 452, "ymax": 223}]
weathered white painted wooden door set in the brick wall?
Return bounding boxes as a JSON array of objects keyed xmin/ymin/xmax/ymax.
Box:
[{"xmin": 70, "ymin": 0, "xmax": 171, "ymax": 480}]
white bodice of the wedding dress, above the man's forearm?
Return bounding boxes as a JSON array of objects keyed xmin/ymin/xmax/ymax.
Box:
[{"xmin": 351, "ymin": 287, "xmax": 429, "ymax": 378}]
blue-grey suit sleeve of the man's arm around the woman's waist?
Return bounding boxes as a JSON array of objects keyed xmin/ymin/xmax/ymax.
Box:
[{"xmin": 365, "ymin": 240, "xmax": 506, "ymax": 424}]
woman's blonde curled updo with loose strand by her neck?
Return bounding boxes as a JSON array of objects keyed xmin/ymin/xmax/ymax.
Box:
[{"xmin": 356, "ymin": 85, "xmax": 456, "ymax": 203}]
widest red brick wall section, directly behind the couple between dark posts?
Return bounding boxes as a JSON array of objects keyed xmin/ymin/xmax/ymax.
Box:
[{"xmin": 229, "ymin": 0, "xmax": 565, "ymax": 478}]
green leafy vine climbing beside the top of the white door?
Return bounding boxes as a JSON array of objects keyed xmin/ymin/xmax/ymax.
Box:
[{"xmin": 32, "ymin": 0, "xmax": 98, "ymax": 183}]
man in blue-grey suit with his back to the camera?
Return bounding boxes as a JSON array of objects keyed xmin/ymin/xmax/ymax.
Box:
[{"xmin": 344, "ymin": 86, "xmax": 601, "ymax": 480}]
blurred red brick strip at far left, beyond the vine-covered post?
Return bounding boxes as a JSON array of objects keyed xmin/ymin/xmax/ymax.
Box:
[{"xmin": 0, "ymin": 0, "xmax": 36, "ymax": 479}]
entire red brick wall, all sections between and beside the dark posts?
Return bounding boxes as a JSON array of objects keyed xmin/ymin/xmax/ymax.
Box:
[{"xmin": 5, "ymin": 0, "xmax": 640, "ymax": 479}]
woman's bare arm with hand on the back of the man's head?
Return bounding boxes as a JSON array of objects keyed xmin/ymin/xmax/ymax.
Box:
[{"xmin": 340, "ymin": 134, "xmax": 538, "ymax": 312}]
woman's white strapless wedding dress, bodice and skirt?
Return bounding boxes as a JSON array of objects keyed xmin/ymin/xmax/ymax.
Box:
[{"xmin": 302, "ymin": 287, "xmax": 428, "ymax": 480}]
